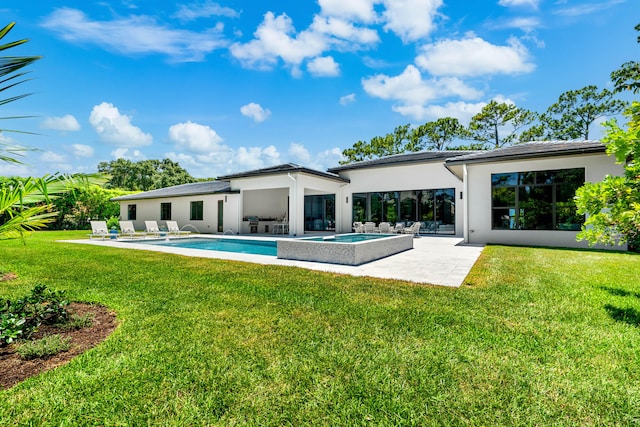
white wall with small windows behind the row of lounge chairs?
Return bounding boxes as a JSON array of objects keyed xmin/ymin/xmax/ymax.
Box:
[{"xmin": 120, "ymin": 194, "xmax": 239, "ymax": 234}]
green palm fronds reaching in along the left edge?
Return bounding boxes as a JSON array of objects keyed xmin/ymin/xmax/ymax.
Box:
[{"xmin": 0, "ymin": 22, "xmax": 97, "ymax": 240}]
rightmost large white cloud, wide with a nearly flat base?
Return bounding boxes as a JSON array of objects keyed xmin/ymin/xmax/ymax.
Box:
[{"xmin": 416, "ymin": 36, "xmax": 535, "ymax": 76}]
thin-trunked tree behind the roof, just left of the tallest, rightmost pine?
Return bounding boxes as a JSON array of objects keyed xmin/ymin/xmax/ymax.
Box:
[{"xmin": 469, "ymin": 101, "xmax": 536, "ymax": 148}]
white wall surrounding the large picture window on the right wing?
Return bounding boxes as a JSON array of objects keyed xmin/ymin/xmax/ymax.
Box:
[{"xmin": 464, "ymin": 153, "xmax": 623, "ymax": 249}]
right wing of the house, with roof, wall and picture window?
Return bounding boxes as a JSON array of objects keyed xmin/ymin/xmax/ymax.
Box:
[{"xmin": 446, "ymin": 141, "xmax": 623, "ymax": 248}]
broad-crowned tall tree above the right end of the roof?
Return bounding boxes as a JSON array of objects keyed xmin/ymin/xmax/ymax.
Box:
[{"xmin": 540, "ymin": 85, "xmax": 626, "ymax": 140}]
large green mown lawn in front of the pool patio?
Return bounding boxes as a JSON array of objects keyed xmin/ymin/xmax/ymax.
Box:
[{"xmin": 0, "ymin": 232, "xmax": 640, "ymax": 426}]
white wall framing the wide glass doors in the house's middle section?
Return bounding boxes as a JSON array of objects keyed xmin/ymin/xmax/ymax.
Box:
[{"xmin": 336, "ymin": 162, "xmax": 466, "ymax": 237}]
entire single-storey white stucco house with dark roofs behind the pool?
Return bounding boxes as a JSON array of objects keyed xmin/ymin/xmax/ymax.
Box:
[{"xmin": 114, "ymin": 141, "xmax": 623, "ymax": 251}]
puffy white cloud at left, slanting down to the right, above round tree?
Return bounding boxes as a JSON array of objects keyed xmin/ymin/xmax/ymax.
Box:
[{"xmin": 89, "ymin": 102, "xmax": 153, "ymax": 148}]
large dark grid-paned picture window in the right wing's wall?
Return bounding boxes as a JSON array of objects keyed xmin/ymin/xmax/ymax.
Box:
[{"xmin": 491, "ymin": 168, "xmax": 585, "ymax": 230}]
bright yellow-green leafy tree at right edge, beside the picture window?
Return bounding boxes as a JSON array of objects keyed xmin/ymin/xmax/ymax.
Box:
[{"xmin": 575, "ymin": 102, "xmax": 640, "ymax": 251}]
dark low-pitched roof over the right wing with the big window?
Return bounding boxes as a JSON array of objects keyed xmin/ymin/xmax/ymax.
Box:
[{"xmin": 446, "ymin": 140, "xmax": 606, "ymax": 165}]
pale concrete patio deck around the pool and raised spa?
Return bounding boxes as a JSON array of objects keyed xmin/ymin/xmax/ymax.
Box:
[{"xmin": 65, "ymin": 235, "xmax": 483, "ymax": 287}]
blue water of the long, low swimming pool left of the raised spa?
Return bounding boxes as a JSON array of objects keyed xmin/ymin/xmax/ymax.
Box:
[{"xmin": 140, "ymin": 238, "xmax": 278, "ymax": 256}]
